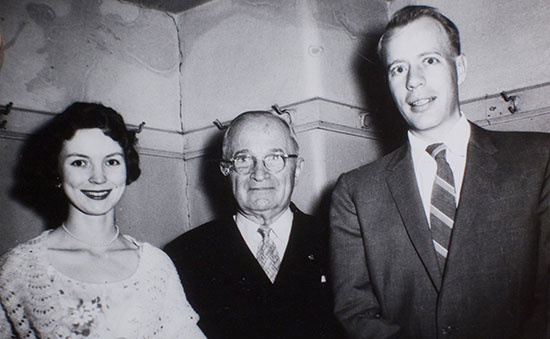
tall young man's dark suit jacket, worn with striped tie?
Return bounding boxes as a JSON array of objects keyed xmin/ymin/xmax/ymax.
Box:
[{"xmin": 330, "ymin": 124, "xmax": 550, "ymax": 338}]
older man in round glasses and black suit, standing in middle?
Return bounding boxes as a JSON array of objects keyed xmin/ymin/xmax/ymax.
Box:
[{"xmin": 166, "ymin": 111, "xmax": 341, "ymax": 339}]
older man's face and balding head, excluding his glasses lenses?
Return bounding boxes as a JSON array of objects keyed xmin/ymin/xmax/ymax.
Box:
[{"xmin": 225, "ymin": 117, "xmax": 303, "ymax": 221}]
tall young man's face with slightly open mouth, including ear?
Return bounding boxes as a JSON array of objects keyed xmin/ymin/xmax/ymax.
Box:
[{"xmin": 384, "ymin": 17, "xmax": 466, "ymax": 139}]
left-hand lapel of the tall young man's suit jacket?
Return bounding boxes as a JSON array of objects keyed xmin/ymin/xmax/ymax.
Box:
[{"xmin": 386, "ymin": 143, "xmax": 441, "ymax": 291}]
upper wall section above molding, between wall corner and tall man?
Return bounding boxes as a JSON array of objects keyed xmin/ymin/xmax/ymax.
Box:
[{"xmin": 178, "ymin": 0, "xmax": 387, "ymax": 130}]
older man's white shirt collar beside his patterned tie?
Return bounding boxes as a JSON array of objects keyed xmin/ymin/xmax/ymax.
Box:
[{"xmin": 233, "ymin": 207, "xmax": 294, "ymax": 260}]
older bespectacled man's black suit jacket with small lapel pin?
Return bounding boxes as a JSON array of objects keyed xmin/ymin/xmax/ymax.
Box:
[{"xmin": 165, "ymin": 206, "xmax": 341, "ymax": 339}]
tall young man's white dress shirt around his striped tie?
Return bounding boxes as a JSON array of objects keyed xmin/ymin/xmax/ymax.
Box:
[{"xmin": 408, "ymin": 114, "xmax": 470, "ymax": 223}]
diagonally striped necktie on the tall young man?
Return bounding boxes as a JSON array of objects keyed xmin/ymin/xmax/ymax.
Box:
[{"xmin": 426, "ymin": 143, "xmax": 456, "ymax": 273}]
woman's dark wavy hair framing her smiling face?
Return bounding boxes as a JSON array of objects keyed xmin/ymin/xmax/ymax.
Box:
[{"xmin": 12, "ymin": 102, "xmax": 141, "ymax": 227}]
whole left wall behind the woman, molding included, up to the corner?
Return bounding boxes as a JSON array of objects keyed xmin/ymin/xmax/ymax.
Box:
[{"xmin": 0, "ymin": 0, "xmax": 187, "ymax": 253}]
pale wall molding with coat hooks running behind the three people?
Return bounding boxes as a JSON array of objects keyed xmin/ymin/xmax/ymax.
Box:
[{"xmin": 0, "ymin": 82, "xmax": 550, "ymax": 160}]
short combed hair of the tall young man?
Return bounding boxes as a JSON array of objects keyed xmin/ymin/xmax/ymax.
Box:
[{"xmin": 377, "ymin": 6, "xmax": 461, "ymax": 62}]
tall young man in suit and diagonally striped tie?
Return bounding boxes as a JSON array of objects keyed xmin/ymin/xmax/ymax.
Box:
[{"xmin": 331, "ymin": 6, "xmax": 550, "ymax": 339}]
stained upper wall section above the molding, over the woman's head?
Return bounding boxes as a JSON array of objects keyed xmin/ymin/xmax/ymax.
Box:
[{"xmin": 0, "ymin": 0, "xmax": 181, "ymax": 130}]
